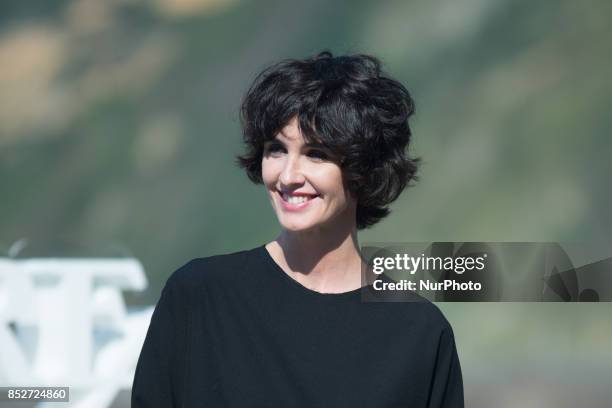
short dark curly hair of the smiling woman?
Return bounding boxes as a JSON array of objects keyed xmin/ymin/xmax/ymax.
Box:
[{"xmin": 238, "ymin": 51, "xmax": 419, "ymax": 229}]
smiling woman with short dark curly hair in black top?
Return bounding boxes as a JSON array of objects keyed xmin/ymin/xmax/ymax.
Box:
[{"xmin": 132, "ymin": 52, "xmax": 463, "ymax": 408}]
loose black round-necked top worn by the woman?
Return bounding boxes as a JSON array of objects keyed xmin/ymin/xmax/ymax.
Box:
[{"xmin": 132, "ymin": 246, "xmax": 463, "ymax": 408}]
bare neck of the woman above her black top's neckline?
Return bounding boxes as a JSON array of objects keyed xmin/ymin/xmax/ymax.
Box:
[{"xmin": 266, "ymin": 223, "xmax": 362, "ymax": 293}]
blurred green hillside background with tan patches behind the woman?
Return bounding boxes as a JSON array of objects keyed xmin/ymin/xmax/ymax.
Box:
[{"xmin": 0, "ymin": 0, "xmax": 612, "ymax": 407}]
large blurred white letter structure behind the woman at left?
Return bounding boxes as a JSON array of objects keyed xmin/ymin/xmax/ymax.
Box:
[{"xmin": 0, "ymin": 258, "xmax": 153, "ymax": 408}]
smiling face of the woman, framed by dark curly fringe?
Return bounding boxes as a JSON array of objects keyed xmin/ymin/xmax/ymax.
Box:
[{"xmin": 261, "ymin": 118, "xmax": 356, "ymax": 231}]
